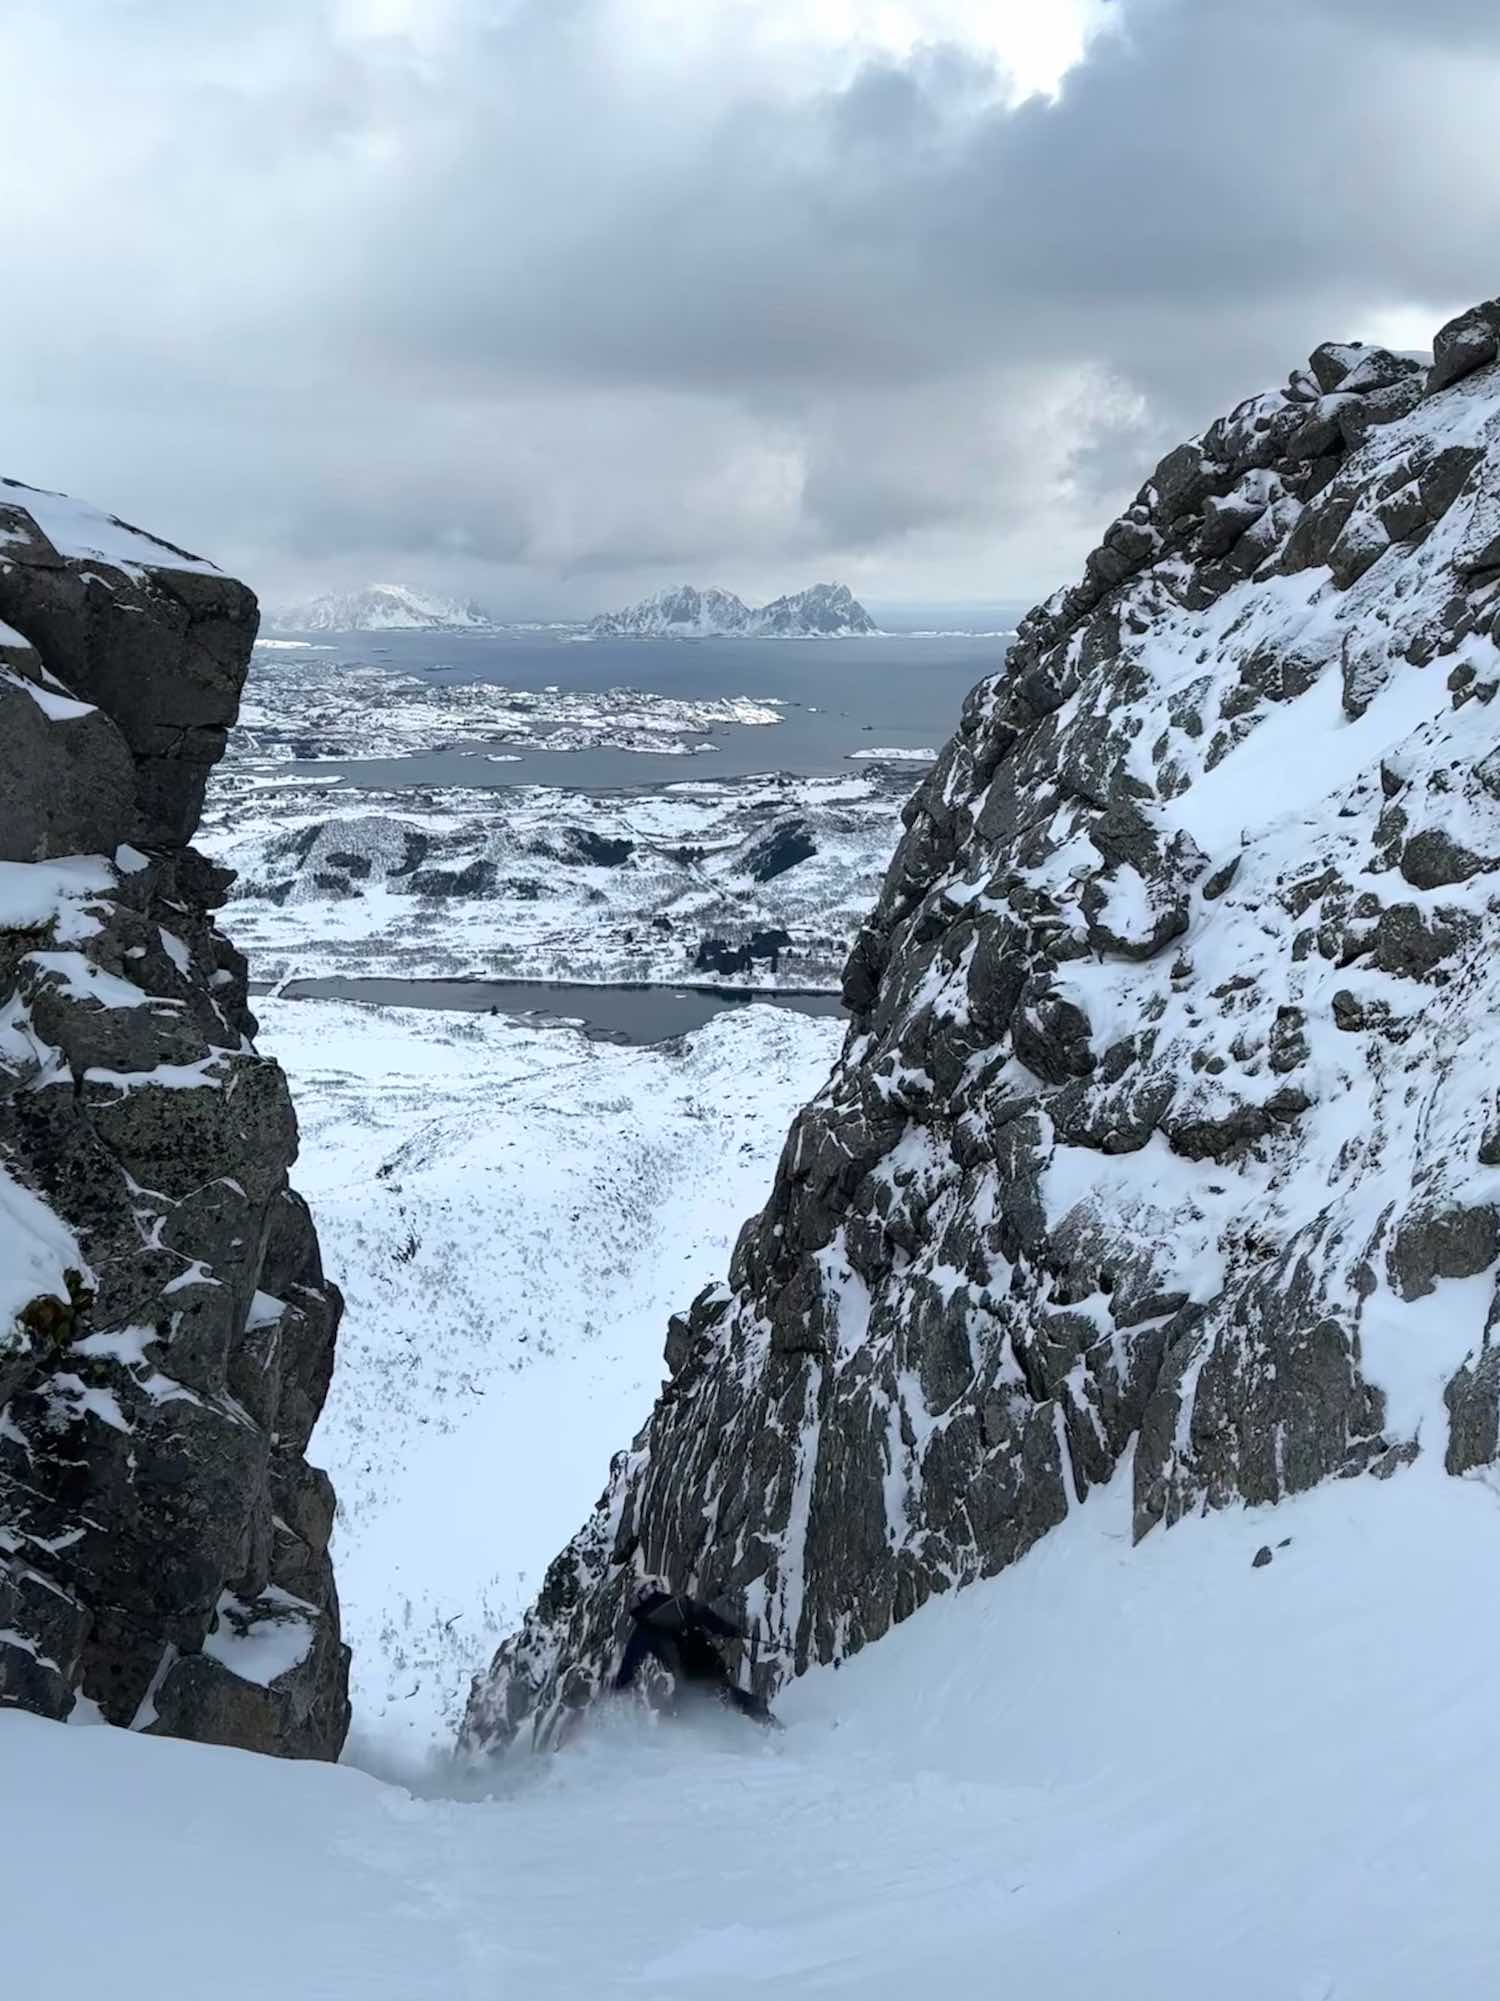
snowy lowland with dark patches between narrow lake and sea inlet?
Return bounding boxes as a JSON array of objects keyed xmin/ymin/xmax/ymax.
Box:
[{"xmin": 200, "ymin": 768, "xmax": 912, "ymax": 988}]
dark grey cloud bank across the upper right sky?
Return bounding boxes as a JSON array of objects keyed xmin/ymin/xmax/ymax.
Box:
[{"xmin": 358, "ymin": 0, "xmax": 1500, "ymax": 398}]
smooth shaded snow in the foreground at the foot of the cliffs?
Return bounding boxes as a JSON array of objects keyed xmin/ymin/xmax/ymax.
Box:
[{"xmin": 11, "ymin": 1455, "xmax": 1500, "ymax": 2001}]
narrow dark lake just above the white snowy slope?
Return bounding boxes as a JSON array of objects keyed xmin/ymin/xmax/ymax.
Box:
[{"xmin": 250, "ymin": 978, "xmax": 844, "ymax": 1043}]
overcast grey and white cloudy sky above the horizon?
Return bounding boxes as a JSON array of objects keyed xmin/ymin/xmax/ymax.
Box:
[{"xmin": 0, "ymin": 0, "xmax": 1500, "ymax": 616}]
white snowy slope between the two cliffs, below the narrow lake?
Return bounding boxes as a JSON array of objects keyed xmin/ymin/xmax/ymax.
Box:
[{"xmin": 258, "ymin": 1001, "xmax": 840, "ymax": 1749}]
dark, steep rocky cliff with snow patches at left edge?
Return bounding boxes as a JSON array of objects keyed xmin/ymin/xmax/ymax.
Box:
[{"xmin": 0, "ymin": 482, "xmax": 348, "ymax": 1757}]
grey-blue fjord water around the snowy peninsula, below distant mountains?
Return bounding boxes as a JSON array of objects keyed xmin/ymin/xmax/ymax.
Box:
[{"xmin": 274, "ymin": 632, "xmax": 1006, "ymax": 790}]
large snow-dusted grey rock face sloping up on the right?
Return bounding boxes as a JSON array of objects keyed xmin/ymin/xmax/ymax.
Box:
[{"xmin": 466, "ymin": 302, "xmax": 1500, "ymax": 1747}]
